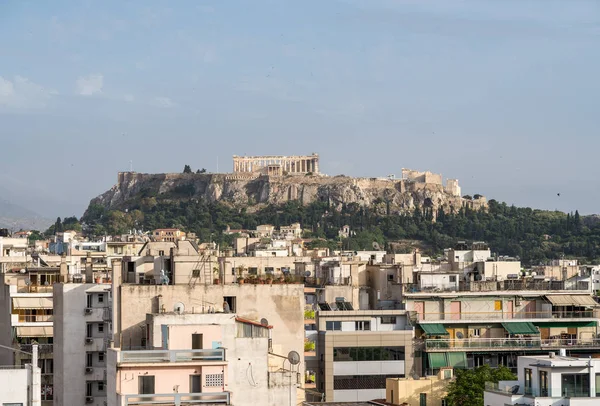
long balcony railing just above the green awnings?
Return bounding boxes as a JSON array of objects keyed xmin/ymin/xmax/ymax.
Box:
[{"xmin": 417, "ymin": 310, "xmax": 600, "ymax": 321}]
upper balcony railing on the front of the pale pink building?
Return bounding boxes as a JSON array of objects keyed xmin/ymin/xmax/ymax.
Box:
[{"xmin": 119, "ymin": 349, "xmax": 225, "ymax": 364}]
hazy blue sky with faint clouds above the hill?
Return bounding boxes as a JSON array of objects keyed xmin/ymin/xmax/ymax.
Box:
[{"xmin": 0, "ymin": 0, "xmax": 600, "ymax": 217}]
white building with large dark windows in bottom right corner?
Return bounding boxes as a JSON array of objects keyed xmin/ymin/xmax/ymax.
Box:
[{"xmin": 484, "ymin": 351, "xmax": 600, "ymax": 406}]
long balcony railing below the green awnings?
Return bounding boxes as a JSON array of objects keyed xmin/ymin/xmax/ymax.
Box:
[{"xmin": 425, "ymin": 338, "xmax": 600, "ymax": 352}]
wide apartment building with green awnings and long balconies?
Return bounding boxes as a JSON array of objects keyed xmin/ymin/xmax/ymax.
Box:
[{"xmin": 405, "ymin": 290, "xmax": 600, "ymax": 374}]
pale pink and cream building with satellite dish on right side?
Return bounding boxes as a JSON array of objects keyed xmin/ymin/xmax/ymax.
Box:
[{"xmin": 107, "ymin": 312, "xmax": 301, "ymax": 406}]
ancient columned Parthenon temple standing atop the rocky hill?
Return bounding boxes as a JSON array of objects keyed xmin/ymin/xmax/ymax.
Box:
[{"xmin": 233, "ymin": 153, "xmax": 319, "ymax": 175}]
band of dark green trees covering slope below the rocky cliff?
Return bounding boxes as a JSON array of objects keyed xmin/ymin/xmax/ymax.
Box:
[{"xmin": 82, "ymin": 197, "xmax": 600, "ymax": 265}]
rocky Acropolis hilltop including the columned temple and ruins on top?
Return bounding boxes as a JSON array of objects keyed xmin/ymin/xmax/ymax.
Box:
[{"xmin": 85, "ymin": 154, "xmax": 487, "ymax": 214}]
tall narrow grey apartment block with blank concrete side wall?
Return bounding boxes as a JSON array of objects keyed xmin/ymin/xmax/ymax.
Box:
[{"xmin": 54, "ymin": 283, "xmax": 112, "ymax": 406}]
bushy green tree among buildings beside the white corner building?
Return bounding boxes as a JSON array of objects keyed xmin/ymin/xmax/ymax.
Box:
[{"xmin": 446, "ymin": 365, "xmax": 517, "ymax": 406}]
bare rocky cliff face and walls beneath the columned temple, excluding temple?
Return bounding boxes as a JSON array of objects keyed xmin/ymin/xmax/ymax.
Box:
[{"xmin": 85, "ymin": 172, "xmax": 487, "ymax": 214}]
